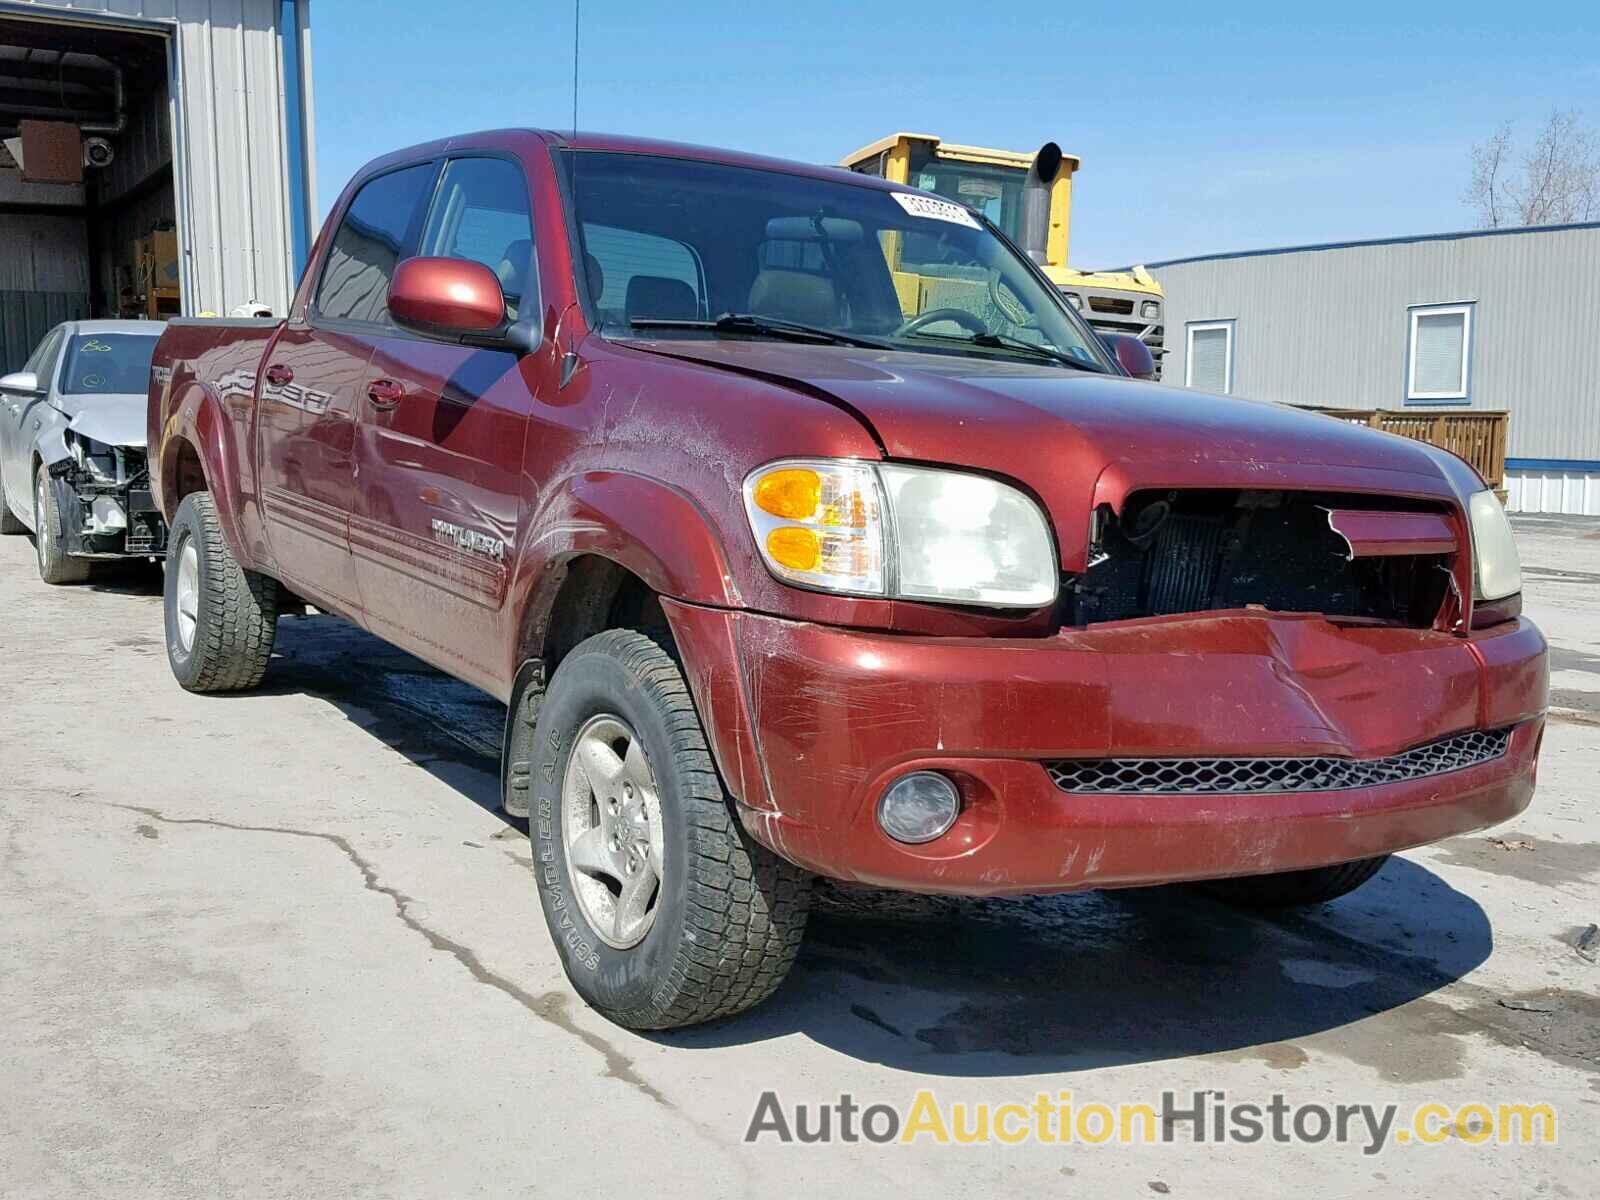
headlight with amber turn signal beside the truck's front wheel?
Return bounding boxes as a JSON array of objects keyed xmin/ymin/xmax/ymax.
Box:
[{"xmin": 744, "ymin": 459, "xmax": 1059, "ymax": 608}]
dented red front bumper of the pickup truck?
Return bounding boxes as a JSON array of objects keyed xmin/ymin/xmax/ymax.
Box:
[{"xmin": 666, "ymin": 603, "xmax": 1547, "ymax": 894}]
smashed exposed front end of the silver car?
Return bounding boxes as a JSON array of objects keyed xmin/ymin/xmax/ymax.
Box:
[{"xmin": 50, "ymin": 446, "xmax": 166, "ymax": 558}]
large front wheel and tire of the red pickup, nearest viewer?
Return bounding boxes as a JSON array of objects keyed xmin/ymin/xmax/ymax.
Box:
[{"xmin": 524, "ymin": 629, "xmax": 811, "ymax": 1029}]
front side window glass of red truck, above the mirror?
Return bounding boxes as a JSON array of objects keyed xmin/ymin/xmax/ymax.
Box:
[{"xmin": 418, "ymin": 158, "xmax": 533, "ymax": 320}]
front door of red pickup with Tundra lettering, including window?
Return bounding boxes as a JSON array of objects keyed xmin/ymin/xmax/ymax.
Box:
[{"xmin": 350, "ymin": 155, "xmax": 539, "ymax": 690}]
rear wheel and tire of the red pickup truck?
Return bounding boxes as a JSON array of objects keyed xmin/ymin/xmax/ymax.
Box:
[{"xmin": 163, "ymin": 491, "xmax": 278, "ymax": 691}]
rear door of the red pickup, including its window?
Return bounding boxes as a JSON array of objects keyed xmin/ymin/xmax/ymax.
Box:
[{"xmin": 256, "ymin": 160, "xmax": 438, "ymax": 618}]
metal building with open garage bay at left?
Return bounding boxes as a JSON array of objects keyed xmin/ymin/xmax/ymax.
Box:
[{"xmin": 0, "ymin": 0, "xmax": 315, "ymax": 371}]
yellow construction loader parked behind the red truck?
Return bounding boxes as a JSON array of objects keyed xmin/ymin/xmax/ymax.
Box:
[{"xmin": 840, "ymin": 133, "xmax": 1165, "ymax": 371}]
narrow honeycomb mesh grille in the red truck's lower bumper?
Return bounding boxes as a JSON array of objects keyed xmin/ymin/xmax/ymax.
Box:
[{"xmin": 1045, "ymin": 730, "xmax": 1510, "ymax": 795}]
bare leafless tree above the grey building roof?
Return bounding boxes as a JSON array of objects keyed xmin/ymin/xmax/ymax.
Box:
[{"xmin": 1462, "ymin": 110, "xmax": 1600, "ymax": 229}]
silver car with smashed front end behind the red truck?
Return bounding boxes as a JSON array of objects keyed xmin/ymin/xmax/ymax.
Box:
[{"xmin": 0, "ymin": 320, "xmax": 166, "ymax": 584}]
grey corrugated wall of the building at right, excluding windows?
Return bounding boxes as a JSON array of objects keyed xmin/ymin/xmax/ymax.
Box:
[{"xmin": 1150, "ymin": 227, "xmax": 1600, "ymax": 461}]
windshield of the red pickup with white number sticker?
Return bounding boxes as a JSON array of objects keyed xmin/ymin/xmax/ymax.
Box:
[{"xmin": 566, "ymin": 150, "xmax": 1107, "ymax": 371}]
